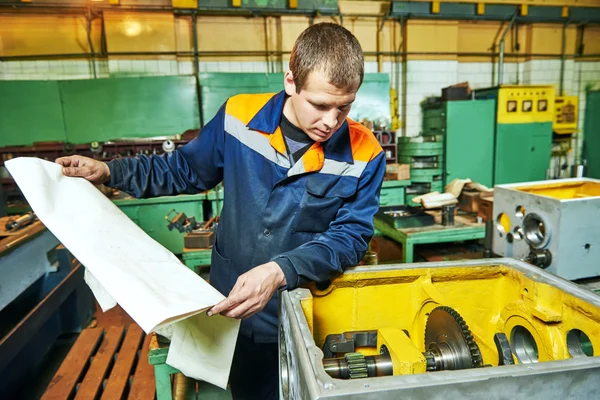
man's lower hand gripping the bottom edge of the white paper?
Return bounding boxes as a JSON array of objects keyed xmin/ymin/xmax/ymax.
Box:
[{"xmin": 208, "ymin": 261, "xmax": 286, "ymax": 319}]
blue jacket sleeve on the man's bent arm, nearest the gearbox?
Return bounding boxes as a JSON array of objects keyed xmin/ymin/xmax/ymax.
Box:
[{"xmin": 271, "ymin": 151, "xmax": 385, "ymax": 290}]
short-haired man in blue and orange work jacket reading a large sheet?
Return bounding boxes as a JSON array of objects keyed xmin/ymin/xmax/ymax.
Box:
[{"xmin": 57, "ymin": 23, "xmax": 385, "ymax": 399}]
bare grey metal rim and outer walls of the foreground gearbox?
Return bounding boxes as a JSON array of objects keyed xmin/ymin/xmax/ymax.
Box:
[{"xmin": 279, "ymin": 259, "xmax": 600, "ymax": 400}]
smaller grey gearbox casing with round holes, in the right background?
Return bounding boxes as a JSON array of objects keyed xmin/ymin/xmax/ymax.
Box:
[{"xmin": 493, "ymin": 178, "xmax": 600, "ymax": 280}]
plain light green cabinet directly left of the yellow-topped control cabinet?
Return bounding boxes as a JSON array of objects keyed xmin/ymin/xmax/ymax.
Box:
[{"xmin": 444, "ymin": 100, "xmax": 496, "ymax": 187}]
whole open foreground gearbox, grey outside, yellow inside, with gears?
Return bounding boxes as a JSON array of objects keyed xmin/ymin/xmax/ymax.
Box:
[{"xmin": 279, "ymin": 259, "xmax": 600, "ymax": 400}]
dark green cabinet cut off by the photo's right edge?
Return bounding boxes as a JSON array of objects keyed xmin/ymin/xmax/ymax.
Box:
[{"xmin": 583, "ymin": 90, "xmax": 600, "ymax": 179}]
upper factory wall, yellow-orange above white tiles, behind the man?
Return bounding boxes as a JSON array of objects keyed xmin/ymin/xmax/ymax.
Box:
[{"xmin": 0, "ymin": 5, "xmax": 600, "ymax": 150}]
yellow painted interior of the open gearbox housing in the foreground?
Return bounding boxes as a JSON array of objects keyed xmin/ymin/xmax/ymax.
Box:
[{"xmin": 303, "ymin": 265, "xmax": 600, "ymax": 375}]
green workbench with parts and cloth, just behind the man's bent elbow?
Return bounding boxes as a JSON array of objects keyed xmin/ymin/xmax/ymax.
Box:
[{"xmin": 375, "ymin": 211, "xmax": 485, "ymax": 263}]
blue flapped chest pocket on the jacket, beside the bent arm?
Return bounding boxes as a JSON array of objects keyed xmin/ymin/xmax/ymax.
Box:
[{"xmin": 292, "ymin": 174, "xmax": 358, "ymax": 233}]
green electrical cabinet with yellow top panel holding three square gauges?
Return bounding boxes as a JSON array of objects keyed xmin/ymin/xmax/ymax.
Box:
[{"xmin": 475, "ymin": 85, "xmax": 555, "ymax": 185}]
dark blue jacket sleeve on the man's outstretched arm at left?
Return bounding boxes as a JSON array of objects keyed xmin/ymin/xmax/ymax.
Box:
[{"xmin": 107, "ymin": 104, "xmax": 226, "ymax": 198}]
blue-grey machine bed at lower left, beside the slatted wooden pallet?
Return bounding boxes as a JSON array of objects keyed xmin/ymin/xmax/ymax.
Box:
[{"xmin": 0, "ymin": 213, "xmax": 95, "ymax": 398}]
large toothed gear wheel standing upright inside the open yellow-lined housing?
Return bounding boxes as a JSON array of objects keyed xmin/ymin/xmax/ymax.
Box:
[{"xmin": 424, "ymin": 306, "xmax": 483, "ymax": 371}]
